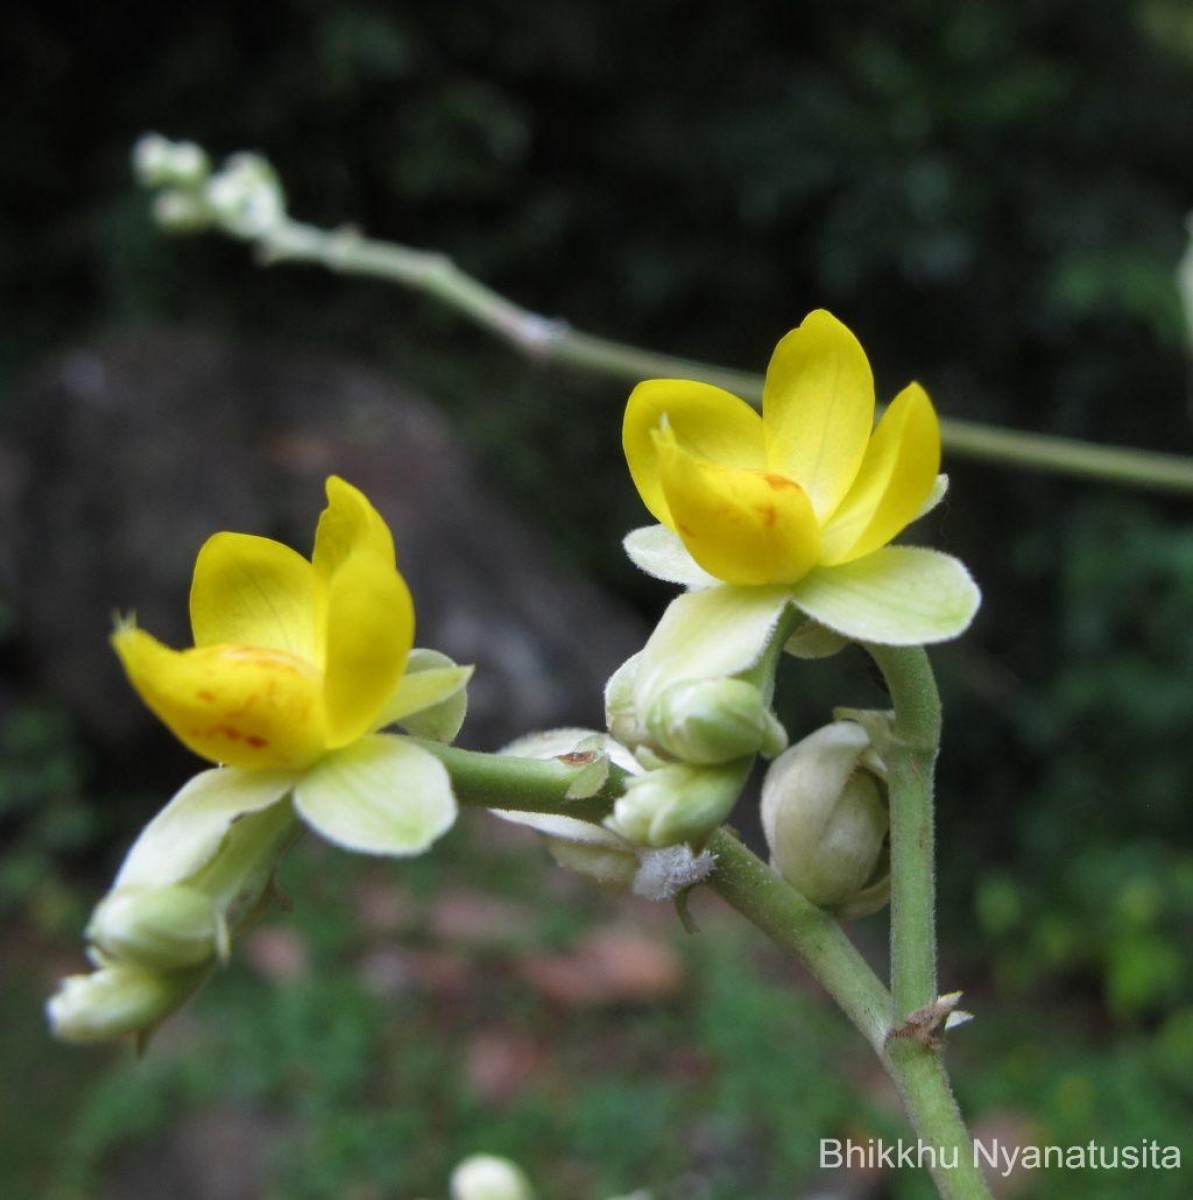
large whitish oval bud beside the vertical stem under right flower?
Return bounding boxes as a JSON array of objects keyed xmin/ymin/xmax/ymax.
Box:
[{"xmin": 762, "ymin": 721, "xmax": 889, "ymax": 917}]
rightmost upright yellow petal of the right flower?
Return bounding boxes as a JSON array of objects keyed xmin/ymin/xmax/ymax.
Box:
[{"xmin": 821, "ymin": 383, "xmax": 940, "ymax": 565}]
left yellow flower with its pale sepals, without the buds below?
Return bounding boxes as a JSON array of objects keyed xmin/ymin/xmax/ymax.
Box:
[{"xmin": 112, "ymin": 476, "xmax": 472, "ymax": 864}]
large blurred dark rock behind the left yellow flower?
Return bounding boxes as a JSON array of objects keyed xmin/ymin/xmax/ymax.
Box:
[{"xmin": 0, "ymin": 329, "xmax": 645, "ymax": 782}]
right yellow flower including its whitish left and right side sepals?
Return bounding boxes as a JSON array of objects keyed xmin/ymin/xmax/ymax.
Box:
[{"xmin": 623, "ymin": 311, "xmax": 978, "ymax": 643}]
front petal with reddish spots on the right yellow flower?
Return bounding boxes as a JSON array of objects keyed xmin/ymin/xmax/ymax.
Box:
[{"xmin": 655, "ymin": 427, "xmax": 820, "ymax": 584}]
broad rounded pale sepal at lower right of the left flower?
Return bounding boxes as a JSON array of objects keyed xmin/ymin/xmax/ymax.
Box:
[{"xmin": 294, "ymin": 733, "xmax": 456, "ymax": 856}]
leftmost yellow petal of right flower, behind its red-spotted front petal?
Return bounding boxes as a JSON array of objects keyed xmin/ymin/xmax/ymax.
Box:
[{"xmin": 622, "ymin": 379, "xmax": 766, "ymax": 528}]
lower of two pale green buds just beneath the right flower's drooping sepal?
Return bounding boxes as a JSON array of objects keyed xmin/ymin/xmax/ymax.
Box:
[{"xmin": 605, "ymin": 758, "xmax": 750, "ymax": 847}]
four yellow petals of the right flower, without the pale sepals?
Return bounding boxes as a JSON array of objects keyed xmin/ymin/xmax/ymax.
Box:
[{"xmin": 624, "ymin": 311, "xmax": 940, "ymax": 584}]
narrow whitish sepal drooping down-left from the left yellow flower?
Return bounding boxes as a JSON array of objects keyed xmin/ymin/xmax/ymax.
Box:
[{"xmin": 113, "ymin": 767, "xmax": 299, "ymax": 890}]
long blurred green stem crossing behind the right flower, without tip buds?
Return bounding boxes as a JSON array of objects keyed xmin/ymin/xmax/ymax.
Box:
[{"xmin": 246, "ymin": 217, "xmax": 1193, "ymax": 494}]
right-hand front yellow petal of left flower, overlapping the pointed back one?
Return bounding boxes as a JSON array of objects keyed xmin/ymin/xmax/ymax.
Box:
[{"xmin": 320, "ymin": 549, "xmax": 414, "ymax": 746}]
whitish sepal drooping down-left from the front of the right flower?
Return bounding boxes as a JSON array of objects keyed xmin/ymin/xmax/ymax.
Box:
[{"xmin": 623, "ymin": 584, "xmax": 791, "ymax": 718}]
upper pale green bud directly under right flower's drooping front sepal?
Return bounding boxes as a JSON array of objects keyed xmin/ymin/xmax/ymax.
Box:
[{"xmin": 646, "ymin": 678, "xmax": 787, "ymax": 764}]
